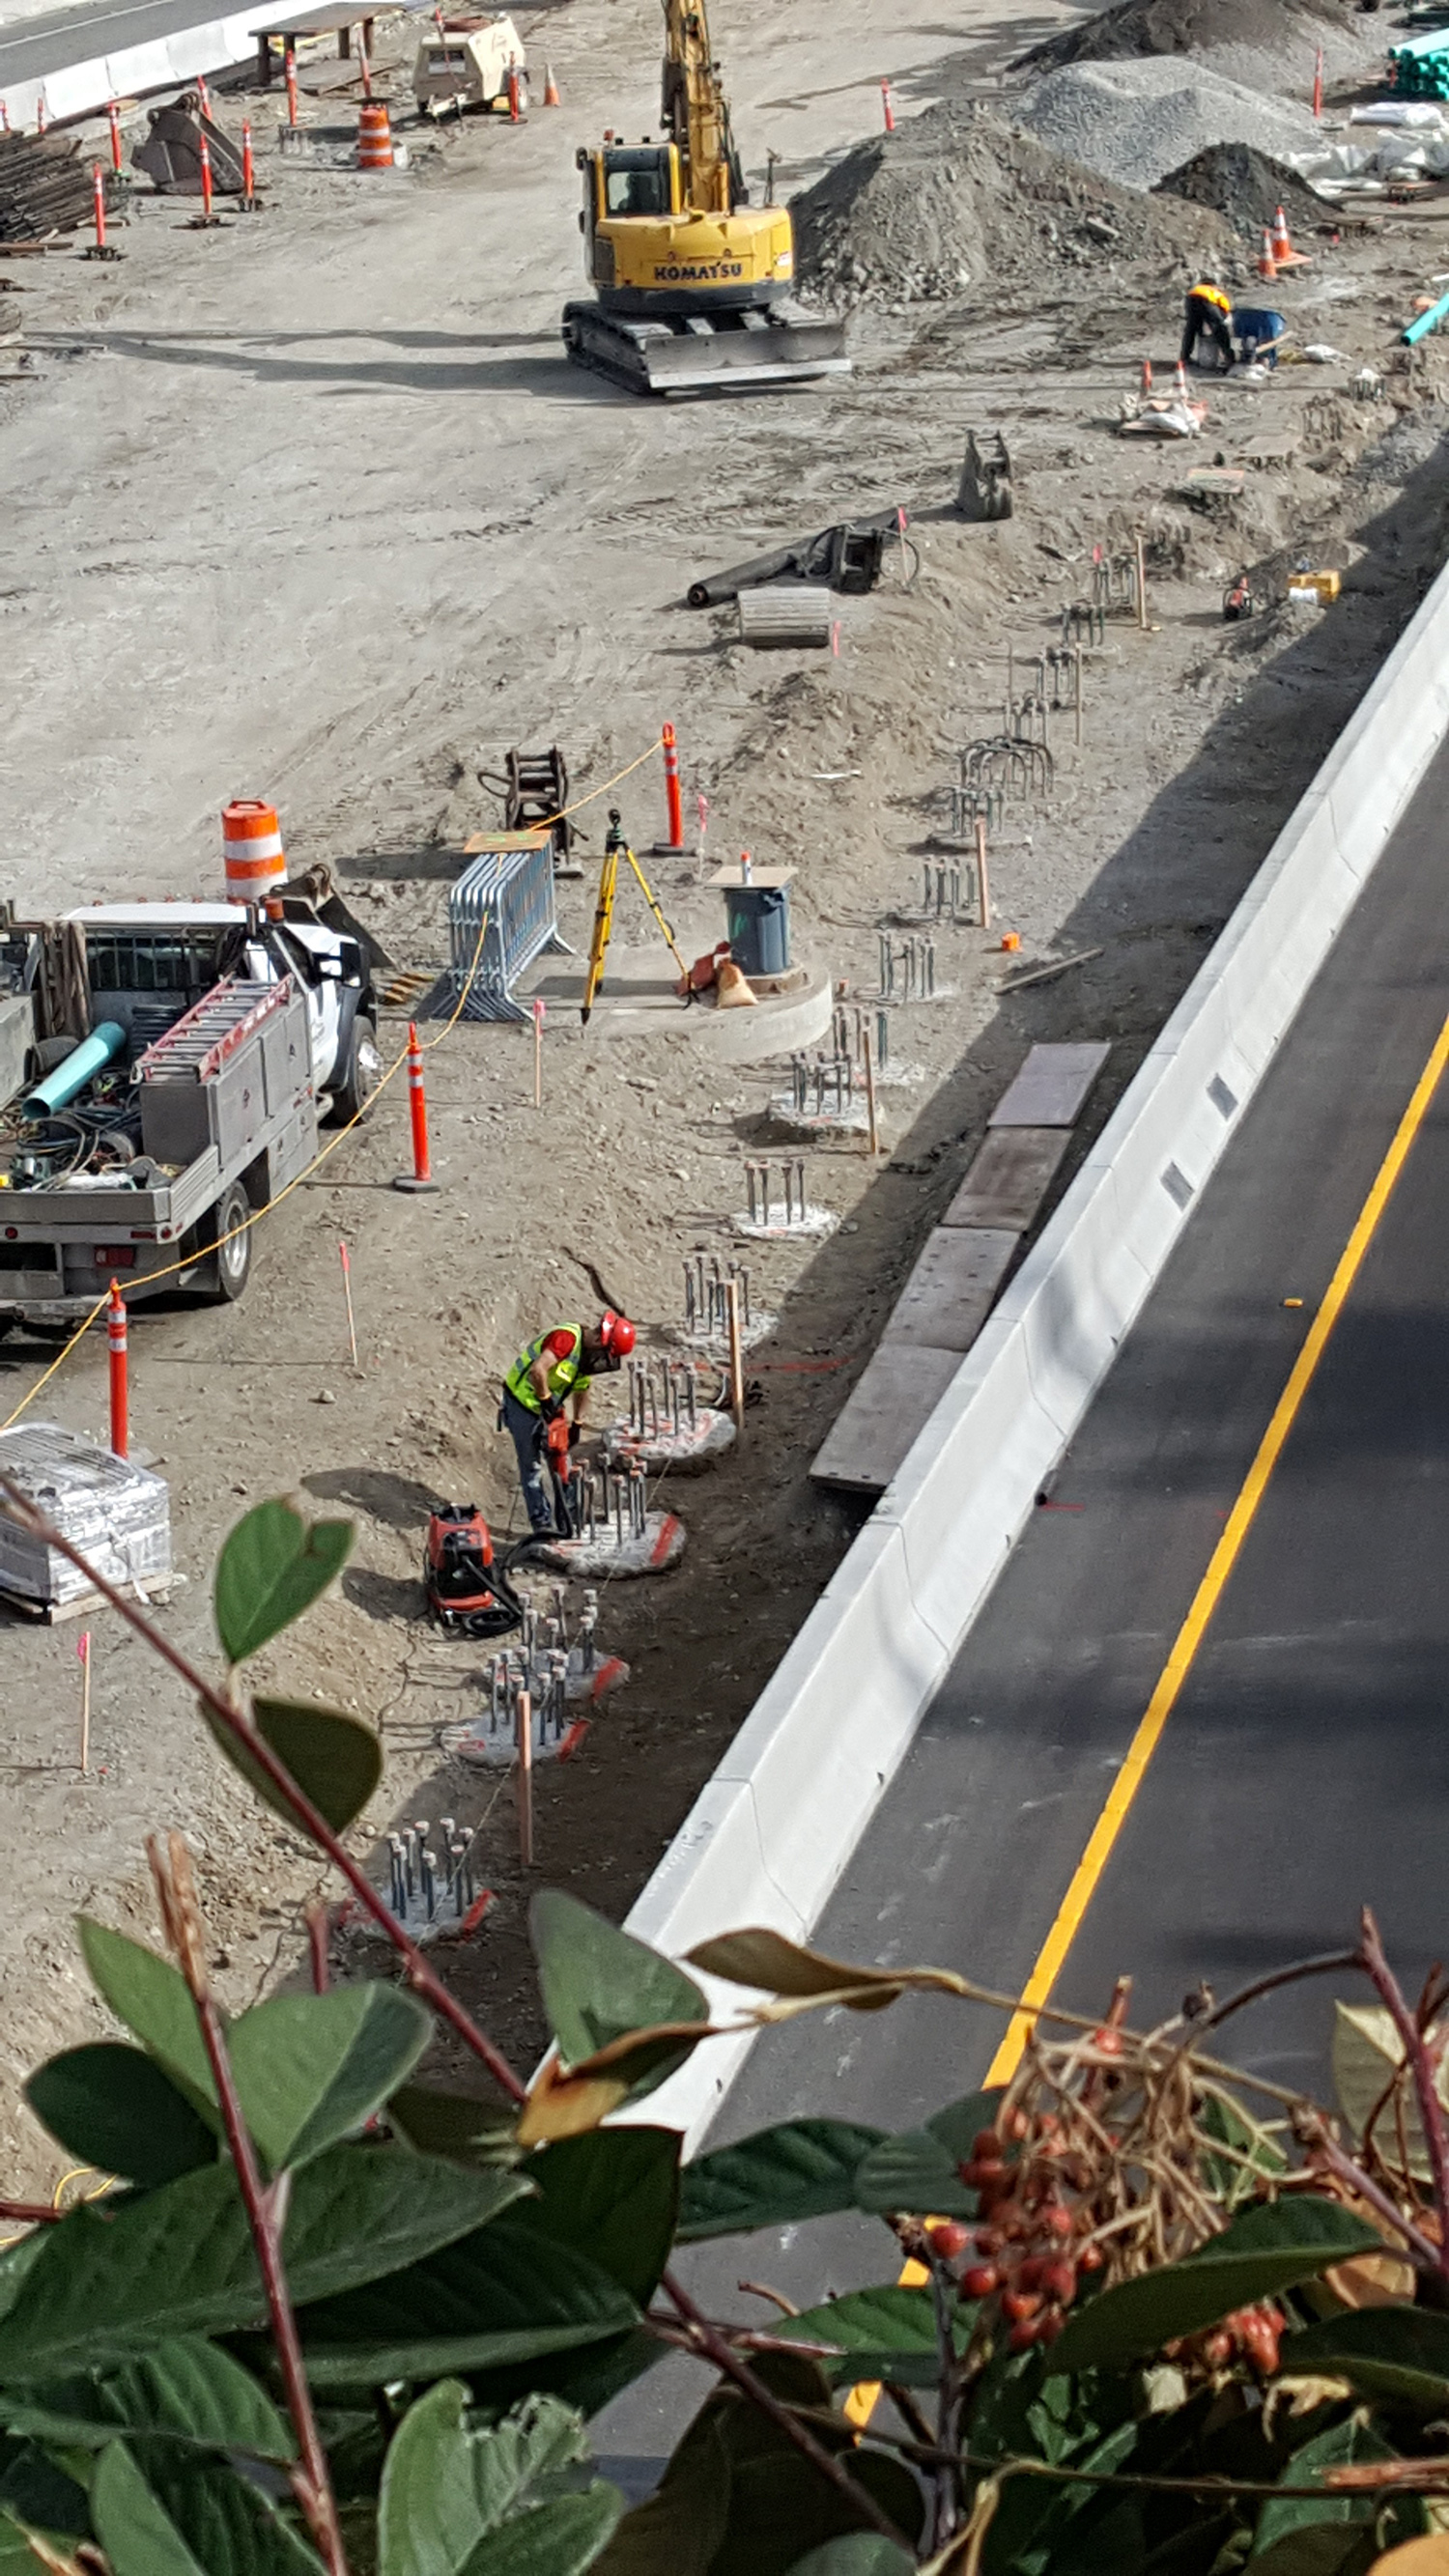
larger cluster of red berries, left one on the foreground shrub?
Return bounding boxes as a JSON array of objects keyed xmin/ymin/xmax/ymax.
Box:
[{"xmin": 925, "ymin": 2112, "xmax": 1101, "ymax": 2352}]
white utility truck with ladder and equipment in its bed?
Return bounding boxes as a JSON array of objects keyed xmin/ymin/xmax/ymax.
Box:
[{"xmin": 0, "ymin": 892, "xmax": 382, "ymax": 1329}]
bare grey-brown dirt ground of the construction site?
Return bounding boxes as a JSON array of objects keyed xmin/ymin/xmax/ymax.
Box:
[{"xmin": 0, "ymin": 0, "xmax": 1449, "ymax": 2190}]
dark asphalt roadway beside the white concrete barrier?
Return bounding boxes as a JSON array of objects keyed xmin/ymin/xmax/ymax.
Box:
[{"xmin": 598, "ymin": 750, "xmax": 1449, "ymax": 2465}]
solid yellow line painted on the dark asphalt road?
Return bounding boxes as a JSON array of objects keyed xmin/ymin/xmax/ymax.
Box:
[{"xmin": 845, "ymin": 994, "xmax": 1449, "ymax": 2426}]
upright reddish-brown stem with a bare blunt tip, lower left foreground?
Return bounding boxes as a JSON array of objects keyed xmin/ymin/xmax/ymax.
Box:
[{"xmin": 147, "ymin": 1834, "xmax": 348, "ymax": 2576}]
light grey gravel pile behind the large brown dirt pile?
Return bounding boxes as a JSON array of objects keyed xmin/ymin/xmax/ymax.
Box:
[{"xmin": 1021, "ymin": 54, "xmax": 1321, "ymax": 188}]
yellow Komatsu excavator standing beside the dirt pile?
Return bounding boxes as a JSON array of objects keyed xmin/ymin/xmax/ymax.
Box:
[{"xmin": 562, "ymin": 0, "xmax": 851, "ymax": 394}]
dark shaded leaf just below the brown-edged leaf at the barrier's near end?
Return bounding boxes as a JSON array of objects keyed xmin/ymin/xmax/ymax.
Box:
[{"xmin": 513, "ymin": 2128, "xmax": 681, "ymax": 2308}]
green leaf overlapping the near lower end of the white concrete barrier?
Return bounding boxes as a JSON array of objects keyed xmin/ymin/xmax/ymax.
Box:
[{"xmin": 528, "ymin": 1888, "xmax": 709, "ymax": 2094}]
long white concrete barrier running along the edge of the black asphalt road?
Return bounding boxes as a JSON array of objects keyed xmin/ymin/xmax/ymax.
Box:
[{"xmin": 629, "ymin": 567, "xmax": 1449, "ymax": 2146}]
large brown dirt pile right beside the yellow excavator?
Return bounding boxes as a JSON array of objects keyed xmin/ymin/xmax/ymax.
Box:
[{"xmin": 789, "ymin": 105, "xmax": 1222, "ymax": 304}]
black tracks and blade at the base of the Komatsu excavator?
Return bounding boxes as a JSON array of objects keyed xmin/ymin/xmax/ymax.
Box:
[{"xmin": 552, "ymin": 301, "xmax": 851, "ymax": 397}]
